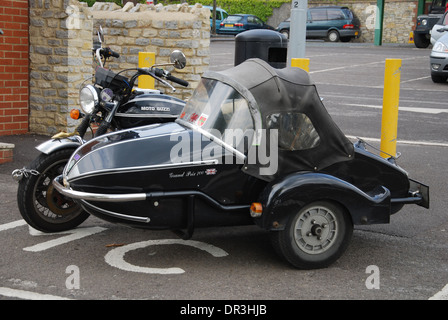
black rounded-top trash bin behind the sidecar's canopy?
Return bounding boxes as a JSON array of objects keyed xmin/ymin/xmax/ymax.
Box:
[{"xmin": 235, "ymin": 29, "xmax": 288, "ymax": 69}]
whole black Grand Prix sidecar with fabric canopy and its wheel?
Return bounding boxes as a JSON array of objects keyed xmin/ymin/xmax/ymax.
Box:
[{"xmin": 53, "ymin": 59, "xmax": 429, "ymax": 268}]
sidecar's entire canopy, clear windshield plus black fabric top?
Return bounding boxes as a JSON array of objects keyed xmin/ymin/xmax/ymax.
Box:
[{"xmin": 176, "ymin": 59, "xmax": 354, "ymax": 181}]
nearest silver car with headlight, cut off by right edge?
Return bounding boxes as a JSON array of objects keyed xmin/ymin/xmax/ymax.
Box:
[{"xmin": 429, "ymin": 33, "xmax": 448, "ymax": 83}]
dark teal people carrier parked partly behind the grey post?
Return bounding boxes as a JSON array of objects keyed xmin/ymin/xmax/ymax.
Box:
[{"xmin": 277, "ymin": 6, "xmax": 361, "ymax": 42}]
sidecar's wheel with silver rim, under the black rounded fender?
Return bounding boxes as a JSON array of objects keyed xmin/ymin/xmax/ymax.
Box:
[{"xmin": 271, "ymin": 201, "xmax": 353, "ymax": 269}]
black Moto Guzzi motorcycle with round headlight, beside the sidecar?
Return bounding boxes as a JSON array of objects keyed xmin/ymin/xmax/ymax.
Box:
[{"xmin": 12, "ymin": 28, "xmax": 188, "ymax": 232}]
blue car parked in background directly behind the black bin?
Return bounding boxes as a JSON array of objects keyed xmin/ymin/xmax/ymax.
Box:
[{"xmin": 217, "ymin": 14, "xmax": 274, "ymax": 35}]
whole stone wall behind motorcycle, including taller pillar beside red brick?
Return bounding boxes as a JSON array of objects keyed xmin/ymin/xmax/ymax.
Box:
[{"xmin": 29, "ymin": 0, "xmax": 210, "ymax": 135}]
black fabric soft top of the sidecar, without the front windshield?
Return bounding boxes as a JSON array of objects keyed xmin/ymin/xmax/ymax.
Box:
[{"xmin": 203, "ymin": 59, "xmax": 354, "ymax": 180}]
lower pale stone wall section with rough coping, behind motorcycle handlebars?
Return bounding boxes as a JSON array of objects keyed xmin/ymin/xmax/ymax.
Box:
[{"xmin": 92, "ymin": 2, "xmax": 210, "ymax": 100}]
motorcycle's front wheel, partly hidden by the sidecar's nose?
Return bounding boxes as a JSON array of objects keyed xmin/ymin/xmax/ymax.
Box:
[{"xmin": 17, "ymin": 149, "xmax": 89, "ymax": 232}]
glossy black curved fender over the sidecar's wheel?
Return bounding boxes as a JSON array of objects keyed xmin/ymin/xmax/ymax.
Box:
[{"xmin": 256, "ymin": 172, "xmax": 391, "ymax": 230}]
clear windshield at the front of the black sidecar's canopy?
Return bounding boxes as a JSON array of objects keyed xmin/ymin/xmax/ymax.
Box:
[{"xmin": 177, "ymin": 78, "xmax": 254, "ymax": 152}]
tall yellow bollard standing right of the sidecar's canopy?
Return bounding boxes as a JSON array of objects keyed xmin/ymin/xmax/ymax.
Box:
[{"xmin": 380, "ymin": 59, "xmax": 401, "ymax": 158}]
